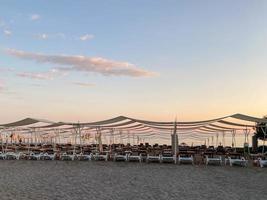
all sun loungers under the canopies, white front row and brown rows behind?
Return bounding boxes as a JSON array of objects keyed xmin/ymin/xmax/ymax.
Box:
[{"xmin": 0, "ymin": 144, "xmax": 267, "ymax": 167}]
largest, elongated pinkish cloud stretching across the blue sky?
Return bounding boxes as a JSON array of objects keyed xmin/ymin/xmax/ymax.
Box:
[{"xmin": 7, "ymin": 49, "xmax": 155, "ymax": 77}]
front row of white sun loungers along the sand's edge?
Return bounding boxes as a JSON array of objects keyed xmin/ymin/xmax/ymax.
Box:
[{"xmin": 0, "ymin": 152, "xmax": 267, "ymax": 167}]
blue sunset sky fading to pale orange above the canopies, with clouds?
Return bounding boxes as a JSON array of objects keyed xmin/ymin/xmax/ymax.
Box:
[{"xmin": 0, "ymin": 0, "xmax": 267, "ymax": 123}]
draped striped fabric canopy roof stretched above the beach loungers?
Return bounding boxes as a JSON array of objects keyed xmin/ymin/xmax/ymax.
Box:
[{"xmin": 0, "ymin": 114, "xmax": 267, "ymax": 146}]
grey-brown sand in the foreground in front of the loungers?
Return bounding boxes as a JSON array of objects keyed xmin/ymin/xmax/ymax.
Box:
[{"xmin": 0, "ymin": 160, "xmax": 267, "ymax": 200}]
